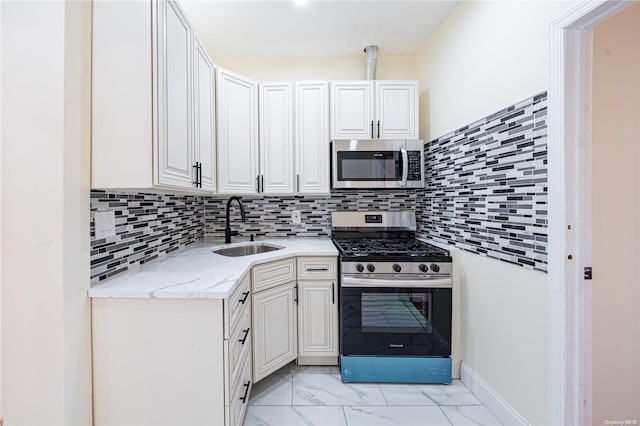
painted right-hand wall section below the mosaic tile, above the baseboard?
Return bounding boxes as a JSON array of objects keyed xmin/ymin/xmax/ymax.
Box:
[{"xmin": 460, "ymin": 251, "xmax": 547, "ymax": 425}]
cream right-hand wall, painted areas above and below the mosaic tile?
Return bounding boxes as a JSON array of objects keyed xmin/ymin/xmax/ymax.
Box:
[{"xmin": 416, "ymin": 1, "xmax": 577, "ymax": 425}]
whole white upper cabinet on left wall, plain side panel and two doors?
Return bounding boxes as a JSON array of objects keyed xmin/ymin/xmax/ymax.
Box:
[{"xmin": 91, "ymin": 0, "xmax": 215, "ymax": 192}]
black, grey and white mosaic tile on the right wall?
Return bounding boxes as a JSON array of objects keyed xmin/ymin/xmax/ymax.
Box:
[{"xmin": 417, "ymin": 92, "xmax": 547, "ymax": 271}]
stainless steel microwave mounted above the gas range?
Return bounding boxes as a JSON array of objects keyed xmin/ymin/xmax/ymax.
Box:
[{"xmin": 331, "ymin": 139, "xmax": 424, "ymax": 189}]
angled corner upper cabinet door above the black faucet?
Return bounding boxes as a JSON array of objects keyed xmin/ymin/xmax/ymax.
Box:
[{"xmin": 216, "ymin": 67, "xmax": 258, "ymax": 194}]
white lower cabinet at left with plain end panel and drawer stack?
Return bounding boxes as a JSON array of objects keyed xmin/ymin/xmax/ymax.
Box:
[{"xmin": 91, "ymin": 275, "xmax": 253, "ymax": 426}]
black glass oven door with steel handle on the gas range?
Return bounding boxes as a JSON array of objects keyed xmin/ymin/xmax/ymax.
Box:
[{"xmin": 340, "ymin": 275, "xmax": 451, "ymax": 357}]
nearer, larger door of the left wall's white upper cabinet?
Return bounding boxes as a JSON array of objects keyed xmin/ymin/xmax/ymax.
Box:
[{"xmin": 155, "ymin": 1, "xmax": 194, "ymax": 189}]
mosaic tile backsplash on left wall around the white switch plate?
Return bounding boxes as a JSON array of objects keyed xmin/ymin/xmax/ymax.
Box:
[{"xmin": 90, "ymin": 190, "xmax": 204, "ymax": 284}]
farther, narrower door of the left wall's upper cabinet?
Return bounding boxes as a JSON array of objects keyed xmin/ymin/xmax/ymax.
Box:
[{"xmin": 193, "ymin": 38, "xmax": 216, "ymax": 192}]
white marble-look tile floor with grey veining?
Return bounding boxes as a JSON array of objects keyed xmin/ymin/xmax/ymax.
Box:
[{"xmin": 244, "ymin": 363, "xmax": 500, "ymax": 426}]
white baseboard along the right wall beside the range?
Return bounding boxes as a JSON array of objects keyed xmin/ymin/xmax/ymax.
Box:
[{"xmin": 460, "ymin": 362, "xmax": 530, "ymax": 426}]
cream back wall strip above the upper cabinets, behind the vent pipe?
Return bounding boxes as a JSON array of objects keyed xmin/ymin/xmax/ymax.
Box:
[{"xmin": 209, "ymin": 52, "xmax": 417, "ymax": 82}]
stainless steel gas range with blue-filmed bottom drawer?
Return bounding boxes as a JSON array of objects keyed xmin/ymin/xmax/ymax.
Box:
[{"xmin": 331, "ymin": 211, "xmax": 452, "ymax": 383}]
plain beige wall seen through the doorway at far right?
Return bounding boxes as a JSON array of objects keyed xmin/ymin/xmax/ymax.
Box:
[{"xmin": 591, "ymin": 4, "xmax": 640, "ymax": 425}]
